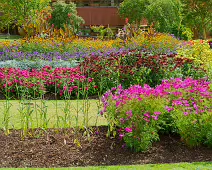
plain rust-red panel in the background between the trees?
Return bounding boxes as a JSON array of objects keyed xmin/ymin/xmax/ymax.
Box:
[{"xmin": 77, "ymin": 7, "xmax": 125, "ymax": 27}]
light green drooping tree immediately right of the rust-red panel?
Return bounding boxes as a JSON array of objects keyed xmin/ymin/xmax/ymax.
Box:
[{"xmin": 119, "ymin": 0, "xmax": 182, "ymax": 32}]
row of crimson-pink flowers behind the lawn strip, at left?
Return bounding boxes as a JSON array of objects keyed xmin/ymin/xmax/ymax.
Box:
[{"xmin": 0, "ymin": 66, "xmax": 92, "ymax": 98}]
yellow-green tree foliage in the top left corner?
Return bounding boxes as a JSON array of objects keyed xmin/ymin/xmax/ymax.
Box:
[{"xmin": 0, "ymin": 0, "xmax": 51, "ymax": 28}]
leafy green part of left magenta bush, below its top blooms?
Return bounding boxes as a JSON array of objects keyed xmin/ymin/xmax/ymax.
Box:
[{"xmin": 104, "ymin": 87, "xmax": 165, "ymax": 152}]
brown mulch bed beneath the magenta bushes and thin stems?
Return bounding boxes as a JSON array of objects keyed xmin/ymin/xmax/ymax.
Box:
[{"xmin": 0, "ymin": 127, "xmax": 212, "ymax": 167}]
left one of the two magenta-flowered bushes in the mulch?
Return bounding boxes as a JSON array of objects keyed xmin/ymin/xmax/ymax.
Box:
[{"xmin": 101, "ymin": 85, "xmax": 165, "ymax": 151}]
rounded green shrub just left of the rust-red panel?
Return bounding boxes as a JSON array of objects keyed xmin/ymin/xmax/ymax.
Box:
[{"xmin": 50, "ymin": 3, "xmax": 84, "ymax": 33}]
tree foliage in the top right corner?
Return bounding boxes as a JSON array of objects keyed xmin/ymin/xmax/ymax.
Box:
[{"xmin": 182, "ymin": 0, "xmax": 212, "ymax": 39}]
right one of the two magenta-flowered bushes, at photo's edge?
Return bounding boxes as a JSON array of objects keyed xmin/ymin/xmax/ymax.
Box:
[{"xmin": 159, "ymin": 78, "xmax": 212, "ymax": 147}]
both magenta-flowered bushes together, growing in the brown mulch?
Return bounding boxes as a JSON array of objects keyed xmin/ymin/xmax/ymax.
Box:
[{"xmin": 101, "ymin": 78, "xmax": 212, "ymax": 151}]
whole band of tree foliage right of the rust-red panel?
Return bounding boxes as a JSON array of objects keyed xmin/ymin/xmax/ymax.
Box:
[{"xmin": 119, "ymin": 0, "xmax": 212, "ymax": 39}]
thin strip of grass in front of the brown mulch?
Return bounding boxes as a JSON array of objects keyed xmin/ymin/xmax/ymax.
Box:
[{"xmin": 2, "ymin": 162, "xmax": 212, "ymax": 170}]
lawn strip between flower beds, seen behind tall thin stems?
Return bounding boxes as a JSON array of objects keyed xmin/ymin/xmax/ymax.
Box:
[{"xmin": 0, "ymin": 100, "xmax": 107, "ymax": 129}]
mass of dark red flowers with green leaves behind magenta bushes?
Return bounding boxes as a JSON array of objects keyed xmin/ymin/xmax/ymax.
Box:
[{"xmin": 79, "ymin": 50, "xmax": 205, "ymax": 94}]
